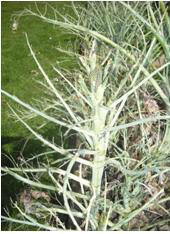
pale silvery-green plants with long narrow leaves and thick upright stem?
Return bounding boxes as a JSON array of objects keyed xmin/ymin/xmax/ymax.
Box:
[{"xmin": 2, "ymin": 2, "xmax": 170, "ymax": 231}]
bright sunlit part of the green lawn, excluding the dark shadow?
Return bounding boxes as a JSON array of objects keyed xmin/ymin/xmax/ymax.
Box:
[{"xmin": 2, "ymin": 2, "xmax": 76, "ymax": 140}]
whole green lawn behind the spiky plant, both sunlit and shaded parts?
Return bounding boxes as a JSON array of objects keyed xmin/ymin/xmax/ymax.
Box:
[{"xmin": 1, "ymin": 2, "xmax": 78, "ymax": 227}]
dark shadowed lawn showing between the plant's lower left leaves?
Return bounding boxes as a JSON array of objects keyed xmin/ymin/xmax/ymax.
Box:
[{"xmin": 1, "ymin": 125, "xmax": 67, "ymax": 218}]
